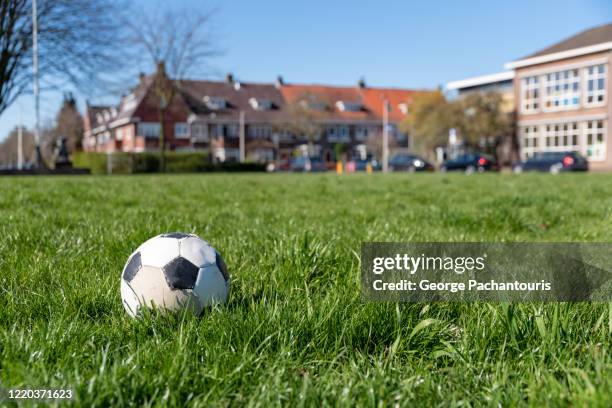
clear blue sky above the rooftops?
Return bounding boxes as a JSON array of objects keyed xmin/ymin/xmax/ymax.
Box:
[{"xmin": 0, "ymin": 0, "xmax": 612, "ymax": 139}]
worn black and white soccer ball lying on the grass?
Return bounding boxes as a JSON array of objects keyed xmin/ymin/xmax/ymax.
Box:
[{"xmin": 121, "ymin": 232, "xmax": 230, "ymax": 317}]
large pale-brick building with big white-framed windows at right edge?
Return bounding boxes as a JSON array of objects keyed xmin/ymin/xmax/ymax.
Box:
[{"xmin": 447, "ymin": 24, "xmax": 612, "ymax": 170}]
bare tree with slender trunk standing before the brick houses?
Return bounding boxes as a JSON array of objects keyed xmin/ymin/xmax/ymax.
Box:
[{"xmin": 125, "ymin": 9, "xmax": 220, "ymax": 171}]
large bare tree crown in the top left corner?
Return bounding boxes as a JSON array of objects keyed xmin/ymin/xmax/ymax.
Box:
[{"xmin": 0, "ymin": 0, "xmax": 126, "ymax": 114}]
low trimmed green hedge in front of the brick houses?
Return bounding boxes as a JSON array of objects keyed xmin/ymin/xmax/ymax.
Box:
[{"xmin": 72, "ymin": 152, "xmax": 265, "ymax": 174}]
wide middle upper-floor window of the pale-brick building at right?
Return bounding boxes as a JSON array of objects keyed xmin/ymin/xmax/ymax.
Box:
[{"xmin": 544, "ymin": 69, "xmax": 580, "ymax": 110}]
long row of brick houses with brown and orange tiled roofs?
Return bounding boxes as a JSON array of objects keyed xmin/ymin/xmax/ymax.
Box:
[{"xmin": 83, "ymin": 64, "xmax": 426, "ymax": 161}]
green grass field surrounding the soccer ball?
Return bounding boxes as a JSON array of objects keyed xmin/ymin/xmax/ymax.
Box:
[{"xmin": 0, "ymin": 174, "xmax": 612, "ymax": 407}]
